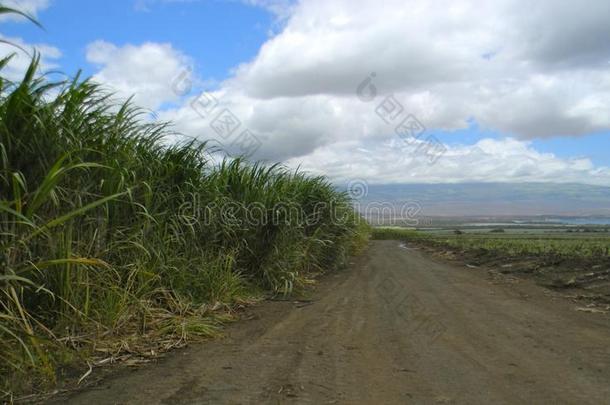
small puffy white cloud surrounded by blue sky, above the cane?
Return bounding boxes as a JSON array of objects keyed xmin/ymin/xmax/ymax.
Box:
[{"xmin": 87, "ymin": 41, "xmax": 191, "ymax": 109}]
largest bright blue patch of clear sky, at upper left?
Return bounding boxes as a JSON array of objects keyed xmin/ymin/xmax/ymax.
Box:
[{"xmin": 2, "ymin": 0, "xmax": 274, "ymax": 80}]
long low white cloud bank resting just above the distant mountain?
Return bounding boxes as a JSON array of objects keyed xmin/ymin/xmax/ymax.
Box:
[{"xmin": 288, "ymin": 138, "xmax": 610, "ymax": 186}]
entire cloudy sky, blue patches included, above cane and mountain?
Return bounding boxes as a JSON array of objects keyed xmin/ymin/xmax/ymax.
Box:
[{"xmin": 0, "ymin": 0, "xmax": 610, "ymax": 185}]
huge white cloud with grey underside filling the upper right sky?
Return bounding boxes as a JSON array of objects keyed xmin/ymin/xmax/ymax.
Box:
[{"xmin": 226, "ymin": 0, "xmax": 610, "ymax": 138}]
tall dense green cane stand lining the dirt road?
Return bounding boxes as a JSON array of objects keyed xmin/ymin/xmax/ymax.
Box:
[{"xmin": 0, "ymin": 58, "xmax": 368, "ymax": 391}]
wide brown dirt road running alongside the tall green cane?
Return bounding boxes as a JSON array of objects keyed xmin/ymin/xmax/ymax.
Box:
[{"xmin": 56, "ymin": 241, "xmax": 610, "ymax": 404}]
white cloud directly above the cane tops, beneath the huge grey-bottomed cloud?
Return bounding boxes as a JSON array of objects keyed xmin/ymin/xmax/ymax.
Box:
[{"xmin": 159, "ymin": 89, "xmax": 384, "ymax": 161}]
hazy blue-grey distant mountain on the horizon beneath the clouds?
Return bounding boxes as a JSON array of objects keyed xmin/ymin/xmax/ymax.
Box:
[{"xmin": 358, "ymin": 183, "xmax": 610, "ymax": 216}]
